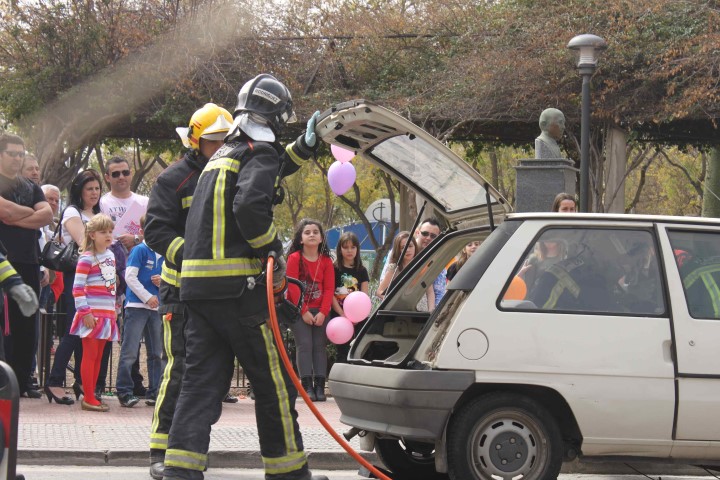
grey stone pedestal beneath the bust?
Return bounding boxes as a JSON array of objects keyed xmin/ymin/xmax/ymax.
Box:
[{"xmin": 515, "ymin": 158, "xmax": 579, "ymax": 212}]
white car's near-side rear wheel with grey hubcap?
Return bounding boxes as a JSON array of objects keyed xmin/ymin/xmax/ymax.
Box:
[{"xmin": 447, "ymin": 393, "xmax": 563, "ymax": 480}]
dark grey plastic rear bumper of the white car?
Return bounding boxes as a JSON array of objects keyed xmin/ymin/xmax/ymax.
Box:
[{"xmin": 329, "ymin": 363, "xmax": 475, "ymax": 441}]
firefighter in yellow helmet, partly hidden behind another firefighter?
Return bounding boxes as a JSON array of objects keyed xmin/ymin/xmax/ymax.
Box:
[{"xmin": 145, "ymin": 103, "xmax": 232, "ymax": 479}]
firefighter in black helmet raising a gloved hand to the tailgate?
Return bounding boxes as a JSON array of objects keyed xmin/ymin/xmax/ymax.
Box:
[{"xmin": 164, "ymin": 74, "xmax": 326, "ymax": 480}]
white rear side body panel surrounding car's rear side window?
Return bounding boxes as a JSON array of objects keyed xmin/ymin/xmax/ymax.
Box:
[{"xmin": 435, "ymin": 221, "xmax": 675, "ymax": 454}]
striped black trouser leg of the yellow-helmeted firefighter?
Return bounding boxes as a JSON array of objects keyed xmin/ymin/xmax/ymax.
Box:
[{"xmin": 150, "ymin": 304, "xmax": 187, "ymax": 463}]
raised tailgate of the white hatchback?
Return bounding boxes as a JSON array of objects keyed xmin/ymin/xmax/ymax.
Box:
[{"xmin": 315, "ymin": 100, "xmax": 511, "ymax": 226}]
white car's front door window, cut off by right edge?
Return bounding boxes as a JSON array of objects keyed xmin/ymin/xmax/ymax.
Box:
[{"xmin": 668, "ymin": 231, "xmax": 720, "ymax": 319}]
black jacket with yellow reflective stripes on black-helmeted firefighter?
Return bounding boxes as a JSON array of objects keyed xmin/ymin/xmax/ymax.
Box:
[{"xmin": 180, "ymin": 136, "xmax": 312, "ymax": 301}]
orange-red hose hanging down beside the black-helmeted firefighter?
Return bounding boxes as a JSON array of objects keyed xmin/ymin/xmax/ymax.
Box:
[{"xmin": 266, "ymin": 256, "xmax": 392, "ymax": 480}]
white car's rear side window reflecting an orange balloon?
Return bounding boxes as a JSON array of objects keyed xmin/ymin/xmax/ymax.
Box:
[{"xmin": 500, "ymin": 228, "xmax": 666, "ymax": 315}]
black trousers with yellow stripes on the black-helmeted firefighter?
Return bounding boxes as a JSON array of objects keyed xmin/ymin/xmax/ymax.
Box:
[{"xmin": 164, "ymin": 297, "xmax": 310, "ymax": 480}]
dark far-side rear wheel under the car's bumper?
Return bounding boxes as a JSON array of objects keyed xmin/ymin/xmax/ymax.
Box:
[{"xmin": 375, "ymin": 438, "xmax": 447, "ymax": 480}]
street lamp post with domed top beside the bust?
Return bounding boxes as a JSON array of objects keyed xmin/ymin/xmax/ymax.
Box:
[{"xmin": 568, "ymin": 33, "xmax": 607, "ymax": 212}]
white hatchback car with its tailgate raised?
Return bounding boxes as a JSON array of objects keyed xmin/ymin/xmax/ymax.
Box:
[{"xmin": 318, "ymin": 101, "xmax": 720, "ymax": 480}]
